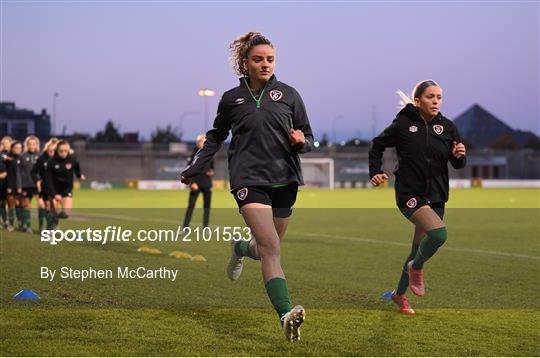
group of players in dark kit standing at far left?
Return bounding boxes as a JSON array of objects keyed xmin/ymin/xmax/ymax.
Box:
[{"xmin": 0, "ymin": 135, "xmax": 85, "ymax": 233}]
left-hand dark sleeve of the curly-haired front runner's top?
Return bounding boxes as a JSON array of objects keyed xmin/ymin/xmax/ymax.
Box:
[{"xmin": 182, "ymin": 97, "xmax": 231, "ymax": 178}]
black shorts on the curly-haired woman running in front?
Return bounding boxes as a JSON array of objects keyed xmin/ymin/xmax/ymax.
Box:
[{"xmin": 232, "ymin": 184, "xmax": 298, "ymax": 218}]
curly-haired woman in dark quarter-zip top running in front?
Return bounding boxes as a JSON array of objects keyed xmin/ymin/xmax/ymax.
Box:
[{"xmin": 182, "ymin": 32, "xmax": 313, "ymax": 341}]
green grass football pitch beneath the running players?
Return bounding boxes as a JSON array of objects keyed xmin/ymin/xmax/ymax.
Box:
[{"xmin": 0, "ymin": 189, "xmax": 540, "ymax": 356}]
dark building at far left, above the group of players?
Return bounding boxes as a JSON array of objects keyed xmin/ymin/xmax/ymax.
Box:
[{"xmin": 0, "ymin": 102, "xmax": 51, "ymax": 140}]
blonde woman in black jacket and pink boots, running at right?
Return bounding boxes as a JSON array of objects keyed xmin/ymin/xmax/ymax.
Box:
[{"xmin": 369, "ymin": 80, "xmax": 466, "ymax": 314}]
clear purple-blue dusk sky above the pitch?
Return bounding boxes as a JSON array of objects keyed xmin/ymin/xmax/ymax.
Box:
[{"xmin": 0, "ymin": 0, "xmax": 540, "ymax": 139}]
